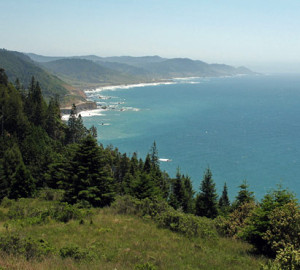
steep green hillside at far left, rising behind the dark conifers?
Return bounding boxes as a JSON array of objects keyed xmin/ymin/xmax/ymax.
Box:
[{"xmin": 0, "ymin": 49, "xmax": 84, "ymax": 103}]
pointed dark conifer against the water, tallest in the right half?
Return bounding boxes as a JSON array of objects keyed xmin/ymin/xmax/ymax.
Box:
[{"xmin": 196, "ymin": 168, "xmax": 218, "ymax": 218}]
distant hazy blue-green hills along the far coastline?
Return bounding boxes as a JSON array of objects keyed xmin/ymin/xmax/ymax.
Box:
[{"xmin": 28, "ymin": 54, "xmax": 253, "ymax": 87}]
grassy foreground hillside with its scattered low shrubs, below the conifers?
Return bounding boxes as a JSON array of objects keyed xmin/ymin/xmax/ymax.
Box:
[{"xmin": 0, "ymin": 195, "xmax": 264, "ymax": 270}]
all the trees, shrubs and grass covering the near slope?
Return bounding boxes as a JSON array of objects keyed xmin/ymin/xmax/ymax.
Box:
[{"xmin": 0, "ymin": 69, "xmax": 300, "ymax": 269}]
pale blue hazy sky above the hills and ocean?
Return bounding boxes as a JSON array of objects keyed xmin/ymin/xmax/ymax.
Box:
[{"xmin": 0, "ymin": 0, "xmax": 300, "ymax": 73}]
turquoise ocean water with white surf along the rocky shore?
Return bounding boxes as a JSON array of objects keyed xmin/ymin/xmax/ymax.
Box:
[{"xmin": 83, "ymin": 75, "xmax": 300, "ymax": 199}]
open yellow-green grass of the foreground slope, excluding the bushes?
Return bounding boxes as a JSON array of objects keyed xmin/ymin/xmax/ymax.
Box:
[{"xmin": 0, "ymin": 199, "xmax": 263, "ymax": 270}]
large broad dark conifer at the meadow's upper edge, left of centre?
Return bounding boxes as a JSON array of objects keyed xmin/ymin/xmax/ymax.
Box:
[{"xmin": 65, "ymin": 135, "xmax": 114, "ymax": 207}]
